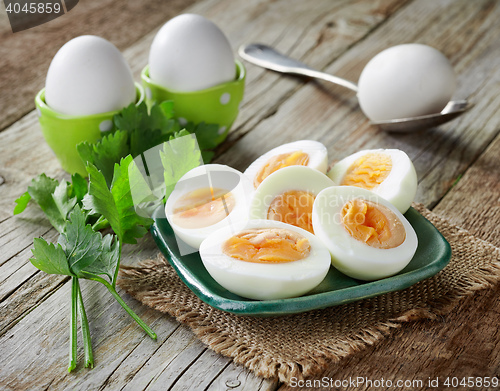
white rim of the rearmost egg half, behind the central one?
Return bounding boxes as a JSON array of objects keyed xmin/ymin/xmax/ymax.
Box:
[{"xmin": 244, "ymin": 140, "xmax": 328, "ymax": 189}]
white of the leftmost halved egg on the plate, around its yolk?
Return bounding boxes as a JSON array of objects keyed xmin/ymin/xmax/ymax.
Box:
[{"xmin": 165, "ymin": 164, "xmax": 253, "ymax": 249}]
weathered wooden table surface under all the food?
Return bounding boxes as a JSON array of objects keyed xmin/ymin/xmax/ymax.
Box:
[{"xmin": 0, "ymin": 0, "xmax": 500, "ymax": 390}]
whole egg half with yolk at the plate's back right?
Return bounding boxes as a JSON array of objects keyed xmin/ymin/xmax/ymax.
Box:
[{"xmin": 328, "ymin": 149, "xmax": 417, "ymax": 213}]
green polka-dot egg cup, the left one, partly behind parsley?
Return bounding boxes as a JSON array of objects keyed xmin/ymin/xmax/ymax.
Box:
[{"xmin": 35, "ymin": 83, "xmax": 144, "ymax": 177}]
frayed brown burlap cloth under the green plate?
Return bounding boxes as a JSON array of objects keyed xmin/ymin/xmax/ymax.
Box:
[{"xmin": 119, "ymin": 205, "xmax": 500, "ymax": 382}]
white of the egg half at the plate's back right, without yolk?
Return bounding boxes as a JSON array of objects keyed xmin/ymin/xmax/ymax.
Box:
[{"xmin": 327, "ymin": 149, "xmax": 418, "ymax": 213}]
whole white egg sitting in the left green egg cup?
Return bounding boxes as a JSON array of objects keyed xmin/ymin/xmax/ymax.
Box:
[{"xmin": 45, "ymin": 35, "xmax": 136, "ymax": 115}]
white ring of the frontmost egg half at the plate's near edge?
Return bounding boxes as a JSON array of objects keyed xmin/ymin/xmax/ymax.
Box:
[{"xmin": 200, "ymin": 220, "xmax": 330, "ymax": 300}]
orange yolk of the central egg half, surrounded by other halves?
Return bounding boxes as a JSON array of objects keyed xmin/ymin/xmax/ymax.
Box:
[{"xmin": 267, "ymin": 190, "xmax": 315, "ymax": 233}]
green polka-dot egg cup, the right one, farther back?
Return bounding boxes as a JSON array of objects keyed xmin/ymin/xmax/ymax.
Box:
[{"xmin": 141, "ymin": 60, "xmax": 246, "ymax": 143}]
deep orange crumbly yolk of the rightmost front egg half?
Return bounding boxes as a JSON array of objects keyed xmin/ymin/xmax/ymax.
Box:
[{"xmin": 341, "ymin": 199, "xmax": 406, "ymax": 249}]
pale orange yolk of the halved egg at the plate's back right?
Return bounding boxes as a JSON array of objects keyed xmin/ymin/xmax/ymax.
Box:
[{"xmin": 340, "ymin": 153, "xmax": 392, "ymax": 190}]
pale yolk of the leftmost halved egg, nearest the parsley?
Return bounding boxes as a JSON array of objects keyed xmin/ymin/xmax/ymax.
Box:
[{"xmin": 172, "ymin": 187, "xmax": 235, "ymax": 229}]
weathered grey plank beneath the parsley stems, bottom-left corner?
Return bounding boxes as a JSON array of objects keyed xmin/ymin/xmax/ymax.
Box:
[{"xmin": 0, "ymin": 281, "xmax": 172, "ymax": 389}]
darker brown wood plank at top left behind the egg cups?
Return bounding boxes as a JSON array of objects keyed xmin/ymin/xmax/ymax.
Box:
[{"xmin": 0, "ymin": 0, "xmax": 199, "ymax": 130}]
